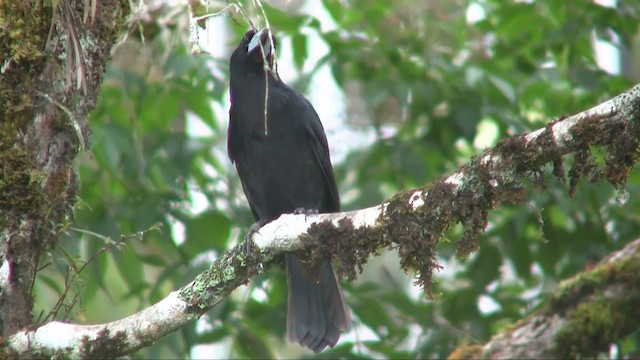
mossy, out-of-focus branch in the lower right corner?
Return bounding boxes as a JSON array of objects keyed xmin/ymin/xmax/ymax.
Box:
[{"xmin": 449, "ymin": 239, "xmax": 640, "ymax": 359}]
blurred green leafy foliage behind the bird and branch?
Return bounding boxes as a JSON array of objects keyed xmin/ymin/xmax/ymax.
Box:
[{"xmin": 34, "ymin": 0, "xmax": 640, "ymax": 358}]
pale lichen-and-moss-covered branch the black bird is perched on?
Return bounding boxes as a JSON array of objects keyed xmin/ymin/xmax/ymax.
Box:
[{"xmin": 7, "ymin": 84, "xmax": 640, "ymax": 357}]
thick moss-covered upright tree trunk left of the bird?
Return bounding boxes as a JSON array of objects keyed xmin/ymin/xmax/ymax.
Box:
[{"xmin": 0, "ymin": 0, "xmax": 129, "ymax": 337}]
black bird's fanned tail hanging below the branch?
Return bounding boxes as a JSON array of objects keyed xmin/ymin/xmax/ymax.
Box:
[{"xmin": 285, "ymin": 254, "xmax": 351, "ymax": 352}]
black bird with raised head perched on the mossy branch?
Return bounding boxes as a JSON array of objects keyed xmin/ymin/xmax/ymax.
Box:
[{"xmin": 227, "ymin": 29, "xmax": 351, "ymax": 352}]
